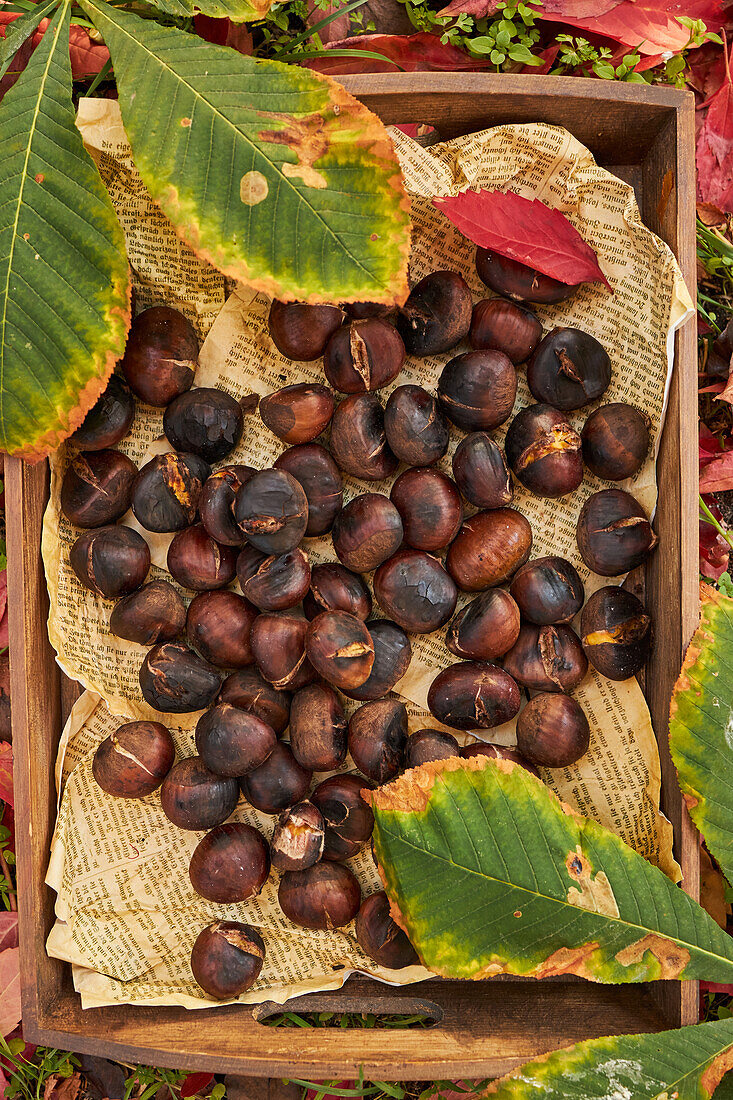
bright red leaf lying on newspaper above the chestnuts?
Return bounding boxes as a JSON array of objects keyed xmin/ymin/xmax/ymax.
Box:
[{"xmin": 433, "ymin": 190, "xmax": 612, "ymax": 289}]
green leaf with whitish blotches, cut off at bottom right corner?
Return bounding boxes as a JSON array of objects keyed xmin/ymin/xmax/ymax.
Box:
[{"xmin": 484, "ymin": 1020, "xmax": 733, "ymax": 1100}]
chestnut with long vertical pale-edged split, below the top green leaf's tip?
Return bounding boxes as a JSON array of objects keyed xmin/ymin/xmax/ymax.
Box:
[{"xmin": 324, "ymin": 317, "xmax": 405, "ymax": 394}]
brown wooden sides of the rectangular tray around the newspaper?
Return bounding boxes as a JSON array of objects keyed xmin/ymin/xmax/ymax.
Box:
[{"xmin": 6, "ymin": 73, "xmax": 699, "ymax": 1080}]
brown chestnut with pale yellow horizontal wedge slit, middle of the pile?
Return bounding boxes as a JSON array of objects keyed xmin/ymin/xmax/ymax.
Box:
[{"xmin": 306, "ymin": 612, "xmax": 374, "ymax": 689}]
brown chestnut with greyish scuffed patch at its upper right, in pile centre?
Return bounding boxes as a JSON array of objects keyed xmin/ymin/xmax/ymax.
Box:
[{"xmin": 331, "ymin": 493, "xmax": 403, "ymax": 573}]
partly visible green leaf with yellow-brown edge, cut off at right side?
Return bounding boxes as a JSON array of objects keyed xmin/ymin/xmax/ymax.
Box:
[{"xmin": 669, "ymin": 584, "xmax": 733, "ymax": 882}]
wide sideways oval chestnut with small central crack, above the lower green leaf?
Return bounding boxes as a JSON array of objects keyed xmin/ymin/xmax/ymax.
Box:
[{"xmin": 428, "ymin": 661, "xmax": 519, "ymax": 729}]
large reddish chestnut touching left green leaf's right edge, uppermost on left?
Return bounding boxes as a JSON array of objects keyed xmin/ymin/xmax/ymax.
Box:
[{"xmin": 121, "ymin": 306, "xmax": 198, "ymax": 408}]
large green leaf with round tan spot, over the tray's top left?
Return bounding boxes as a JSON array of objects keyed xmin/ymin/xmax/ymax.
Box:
[{"xmin": 81, "ymin": 0, "xmax": 409, "ymax": 301}]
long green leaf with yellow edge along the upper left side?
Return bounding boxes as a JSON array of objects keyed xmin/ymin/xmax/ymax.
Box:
[{"xmin": 0, "ymin": 0, "xmax": 130, "ymax": 459}]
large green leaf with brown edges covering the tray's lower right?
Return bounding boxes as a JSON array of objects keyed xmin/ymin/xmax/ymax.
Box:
[{"xmin": 370, "ymin": 757, "xmax": 733, "ymax": 982}]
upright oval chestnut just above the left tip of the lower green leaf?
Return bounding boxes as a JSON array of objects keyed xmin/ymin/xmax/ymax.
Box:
[{"xmin": 349, "ymin": 699, "xmax": 407, "ymax": 783}]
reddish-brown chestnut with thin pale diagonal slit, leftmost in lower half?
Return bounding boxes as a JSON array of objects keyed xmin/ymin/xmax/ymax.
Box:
[{"xmin": 91, "ymin": 722, "xmax": 176, "ymax": 799}]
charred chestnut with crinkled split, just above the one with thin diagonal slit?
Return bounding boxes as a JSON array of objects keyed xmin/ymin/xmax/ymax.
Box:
[{"xmin": 140, "ymin": 641, "xmax": 220, "ymax": 714}]
